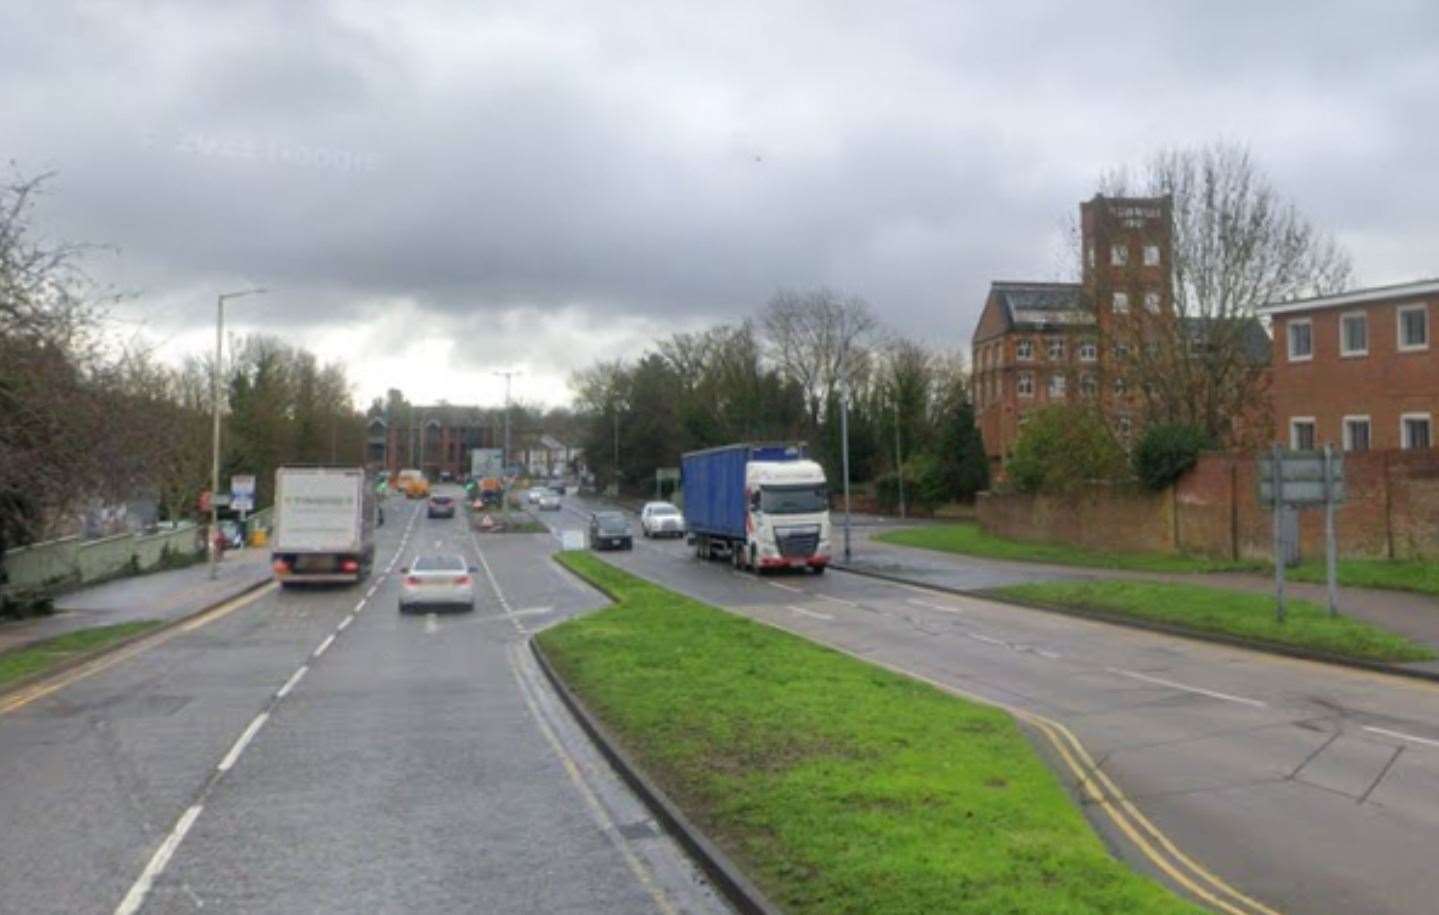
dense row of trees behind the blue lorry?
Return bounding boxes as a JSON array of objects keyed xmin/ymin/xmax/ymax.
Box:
[{"xmin": 571, "ymin": 288, "xmax": 987, "ymax": 508}]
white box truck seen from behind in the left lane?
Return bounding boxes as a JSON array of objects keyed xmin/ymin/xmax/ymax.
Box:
[{"xmin": 271, "ymin": 466, "xmax": 377, "ymax": 584}]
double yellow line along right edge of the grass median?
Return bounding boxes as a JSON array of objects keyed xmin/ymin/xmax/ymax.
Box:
[{"xmin": 748, "ymin": 617, "xmax": 1279, "ymax": 915}]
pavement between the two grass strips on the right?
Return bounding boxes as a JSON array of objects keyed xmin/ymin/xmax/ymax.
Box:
[{"xmin": 837, "ymin": 521, "xmax": 1439, "ymax": 672}]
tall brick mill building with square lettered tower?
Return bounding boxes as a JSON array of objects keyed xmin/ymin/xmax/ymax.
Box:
[{"xmin": 971, "ymin": 196, "xmax": 1174, "ymax": 470}]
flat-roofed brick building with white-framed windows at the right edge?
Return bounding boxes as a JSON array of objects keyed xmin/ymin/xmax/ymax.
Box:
[{"xmin": 1259, "ymin": 279, "xmax": 1439, "ymax": 452}]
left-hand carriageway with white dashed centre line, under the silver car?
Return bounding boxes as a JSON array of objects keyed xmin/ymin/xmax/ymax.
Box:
[{"xmin": 0, "ymin": 489, "xmax": 725, "ymax": 914}]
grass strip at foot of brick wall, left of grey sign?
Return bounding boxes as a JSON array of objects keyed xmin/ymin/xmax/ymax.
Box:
[{"xmin": 875, "ymin": 522, "xmax": 1265, "ymax": 573}]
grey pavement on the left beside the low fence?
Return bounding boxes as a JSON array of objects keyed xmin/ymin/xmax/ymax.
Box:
[{"xmin": 0, "ymin": 547, "xmax": 271, "ymax": 652}]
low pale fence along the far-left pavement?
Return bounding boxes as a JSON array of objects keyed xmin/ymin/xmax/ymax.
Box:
[{"xmin": 4, "ymin": 524, "xmax": 201, "ymax": 594}]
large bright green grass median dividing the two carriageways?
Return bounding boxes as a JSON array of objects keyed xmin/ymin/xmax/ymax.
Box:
[{"xmin": 537, "ymin": 552, "xmax": 1196, "ymax": 915}]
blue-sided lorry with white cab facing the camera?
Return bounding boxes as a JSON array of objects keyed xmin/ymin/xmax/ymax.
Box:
[{"xmin": 679, "ymin": 443, "xmax": 830, "ymax": 574}]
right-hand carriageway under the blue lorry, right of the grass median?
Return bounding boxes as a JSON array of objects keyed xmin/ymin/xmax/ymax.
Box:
[{"xmin": 557, "ymin": 504, "xmax": 1439, "ymax": 912}]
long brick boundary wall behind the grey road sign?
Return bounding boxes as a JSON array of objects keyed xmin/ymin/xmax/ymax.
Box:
[{"xmin": 977, "ymin": 449, "xmax": 1439, "ymax": 560}]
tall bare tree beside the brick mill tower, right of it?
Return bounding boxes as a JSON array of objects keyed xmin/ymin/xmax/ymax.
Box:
[{"xmin": 1101, "ymin": 144, "xmax": 1353, "ymax": 445}]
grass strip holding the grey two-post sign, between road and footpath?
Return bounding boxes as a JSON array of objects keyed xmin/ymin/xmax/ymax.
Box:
[{"xmin": 989, "ymin": 580, "xmax": 1435, "ymax": 660}]
